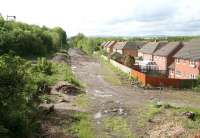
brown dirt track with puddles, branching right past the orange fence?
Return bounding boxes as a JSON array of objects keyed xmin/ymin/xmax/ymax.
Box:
[{"xmin": 69, "ymin": 49, "xmax": 200, "ymax": 137}]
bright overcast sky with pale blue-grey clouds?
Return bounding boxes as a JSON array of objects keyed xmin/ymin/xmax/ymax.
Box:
[{"xmin": 0, "ymin": 0, "xmax": 200, "ymax": 36}]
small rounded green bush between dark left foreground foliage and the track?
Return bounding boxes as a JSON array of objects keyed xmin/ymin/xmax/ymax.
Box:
[{"xmin": 36, "ymin": 57, "xmax": 53, "ymax": 75}]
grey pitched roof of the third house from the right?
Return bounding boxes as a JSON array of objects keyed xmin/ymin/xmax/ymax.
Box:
[{"xmin": 139, "ymin": 42, "xmax": 167, "ymax": 54}]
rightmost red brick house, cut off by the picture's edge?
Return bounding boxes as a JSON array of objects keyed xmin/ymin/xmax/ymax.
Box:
[{"xmin": 169, "ymin": 40, "xmax": 200, "ymax": 79}]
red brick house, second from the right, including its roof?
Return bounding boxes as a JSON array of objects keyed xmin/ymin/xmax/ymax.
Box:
[{"xmin": 153, "ymin": 42, "xmax": 182, "ymax": 72}]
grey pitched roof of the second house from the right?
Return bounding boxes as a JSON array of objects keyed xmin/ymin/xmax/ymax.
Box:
[{"xmin": 154, "ymin": 42, "xmax": 181, "ymax": 56}]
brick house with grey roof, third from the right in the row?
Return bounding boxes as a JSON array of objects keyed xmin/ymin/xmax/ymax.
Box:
[{"xmin": 138, "ymin": 42, "xmax": 166, "ymax": 61}]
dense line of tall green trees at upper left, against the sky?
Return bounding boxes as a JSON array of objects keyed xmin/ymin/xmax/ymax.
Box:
[{"xmin": 0, "ymin": 17, "xmax": 67, "ymax": 56}]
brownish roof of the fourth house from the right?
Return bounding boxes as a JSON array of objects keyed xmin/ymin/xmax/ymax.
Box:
[{"xmin": 123, "ymin": 41, "xmax": 145, "ymax": 50}]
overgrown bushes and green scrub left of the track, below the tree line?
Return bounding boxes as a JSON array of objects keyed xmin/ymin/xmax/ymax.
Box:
[{"xmin": 0, "ymin": 51, "xmax": 80, "ymax": 138}]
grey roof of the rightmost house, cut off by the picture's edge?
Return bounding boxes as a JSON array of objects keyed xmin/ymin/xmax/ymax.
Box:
[{"xmin": 174, "ymin": 39, "xmax": 200, "ymax": 60}]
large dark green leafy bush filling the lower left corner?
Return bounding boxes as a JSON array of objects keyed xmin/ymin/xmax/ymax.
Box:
[{"xmin": 0, "ymin": 55, "xmax": 38, "ymax": 138}]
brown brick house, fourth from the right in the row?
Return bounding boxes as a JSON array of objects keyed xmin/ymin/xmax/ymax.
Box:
[{"xmin": 123, "ymin": 41, "xmax": 145, "ymax": 57}]
